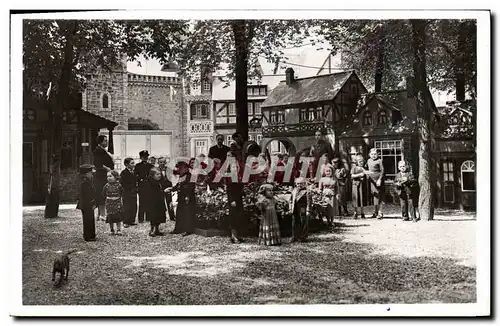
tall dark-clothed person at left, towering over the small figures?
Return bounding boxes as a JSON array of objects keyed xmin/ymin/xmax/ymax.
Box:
[{"xmin": 92, "ymin": 135, "xmax": 115, "ymax": 221}]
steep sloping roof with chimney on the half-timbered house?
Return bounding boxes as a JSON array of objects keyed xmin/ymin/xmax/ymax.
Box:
[{"xmin": 262, "ymin": 70, "xmax": 354, "ymax": 107}]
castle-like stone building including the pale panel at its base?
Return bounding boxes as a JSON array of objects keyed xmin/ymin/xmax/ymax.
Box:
[{"xmin": 83, "ymin": 59, "xmax": 188, "ymax": 170}]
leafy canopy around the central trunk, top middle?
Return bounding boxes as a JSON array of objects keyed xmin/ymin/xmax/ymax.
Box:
[{"xmin": 142, "ymin": 20, "xmax": 320, "ymax": 83}]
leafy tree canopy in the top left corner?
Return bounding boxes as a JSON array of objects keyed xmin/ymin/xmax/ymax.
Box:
[{"xmin": 23, "ymin": 20, "xmax": 188, "ymax": 100}]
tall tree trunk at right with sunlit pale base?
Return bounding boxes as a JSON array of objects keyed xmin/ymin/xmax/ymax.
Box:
[{"xmin": 411, "ymin": 19, "xmax": 434, "ymax": 220}]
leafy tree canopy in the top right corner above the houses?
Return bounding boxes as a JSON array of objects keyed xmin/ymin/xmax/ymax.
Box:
[{"xmin": 318, "ymin": 20, "xmax": 476, "ymax": 95}]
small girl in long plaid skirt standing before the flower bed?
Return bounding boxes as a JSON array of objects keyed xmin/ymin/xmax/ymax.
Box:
[{"xmin": 257, "ymin": 184, "xmax": 281, "ymax": 246}]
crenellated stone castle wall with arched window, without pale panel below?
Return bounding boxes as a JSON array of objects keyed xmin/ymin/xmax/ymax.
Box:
[{"xmin": 83, "ymin": 67, "xmax": 187, "ymax": 156}]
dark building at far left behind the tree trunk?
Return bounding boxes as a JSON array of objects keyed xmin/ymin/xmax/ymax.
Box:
[{"xmin": 22, "ymin": 96, "xmax": 117, "ymax": 204}]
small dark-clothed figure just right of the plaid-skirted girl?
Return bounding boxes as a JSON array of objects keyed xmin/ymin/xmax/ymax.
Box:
[{"xmin": 290, "ymin": 177, "xmax": 312, "ymax": 242}]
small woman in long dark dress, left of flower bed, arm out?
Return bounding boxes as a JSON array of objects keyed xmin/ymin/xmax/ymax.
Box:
[{"xmin": 167, "ymin": 162, "xmax": 196, "ymax": 236}]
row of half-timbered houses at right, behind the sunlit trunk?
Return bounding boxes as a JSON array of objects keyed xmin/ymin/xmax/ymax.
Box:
[{"xmin": 262, "ymin": 69, "xmax": 476, "ymax": 209}]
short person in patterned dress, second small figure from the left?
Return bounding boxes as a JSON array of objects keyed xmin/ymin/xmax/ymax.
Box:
[{"xmin": 102, "ymin": 170, "xmax": 123, "ymax": 235}]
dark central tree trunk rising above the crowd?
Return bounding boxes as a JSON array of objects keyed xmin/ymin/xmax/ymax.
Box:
[{"xmin": 232, "ymin": 20, "xmax": 249, "ymax": 141}]
